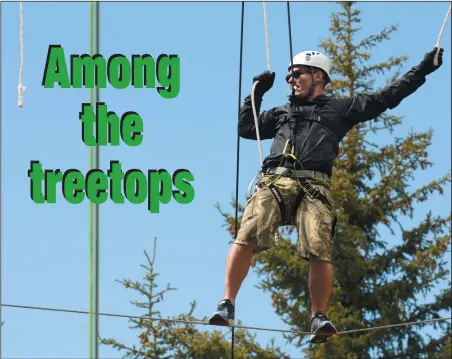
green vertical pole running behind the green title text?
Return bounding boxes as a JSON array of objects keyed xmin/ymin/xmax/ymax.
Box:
[{"xmin": 89, "ymin": 2, "xmax": 99, "ymax": 359}]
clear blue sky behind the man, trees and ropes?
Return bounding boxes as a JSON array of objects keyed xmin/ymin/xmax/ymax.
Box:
[{"xmin": 1, "ymin": 2, "xmax": 451, "ymax": 358}]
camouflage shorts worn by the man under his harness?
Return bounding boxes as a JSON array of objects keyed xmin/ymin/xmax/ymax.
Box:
[{"xmin": 234, "ymin": 175, "xmax": 336, "ymax": 262}]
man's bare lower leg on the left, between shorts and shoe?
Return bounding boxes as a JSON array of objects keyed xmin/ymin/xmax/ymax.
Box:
[{"xmin": 224, "ymin": 243, "xmax": 255, "ymax": 304}]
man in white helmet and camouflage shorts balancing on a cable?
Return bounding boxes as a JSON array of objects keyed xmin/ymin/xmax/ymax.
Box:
[{"xmin": 209, "ymin": 47, "xmax": 443, "ymax": 343}]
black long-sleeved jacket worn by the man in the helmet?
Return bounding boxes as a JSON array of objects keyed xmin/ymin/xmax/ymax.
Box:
[{"xmin": 238, "ymin": 66, "xmax": 425, "ymax": 176}]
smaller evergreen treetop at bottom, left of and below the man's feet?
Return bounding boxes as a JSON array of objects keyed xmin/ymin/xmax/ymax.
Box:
[{"xmin": 101, "ymin": 241, "xmax": 289, "ymax": 359}]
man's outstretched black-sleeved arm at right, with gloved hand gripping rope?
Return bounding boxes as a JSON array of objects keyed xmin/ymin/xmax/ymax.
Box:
[{"xmin": 342, "ymin": 48, "xmax": 443, "ymax": 127}]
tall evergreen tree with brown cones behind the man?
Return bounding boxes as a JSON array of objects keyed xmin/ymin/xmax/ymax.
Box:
[{"xmin": 220, "ymin": 2, "xmax": 451, "ymax": 359}]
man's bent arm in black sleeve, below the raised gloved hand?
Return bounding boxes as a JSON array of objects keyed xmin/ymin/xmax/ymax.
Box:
[{"xmin": 238, "ymin": 95, "xmax": 278, "ymax": 140}]
